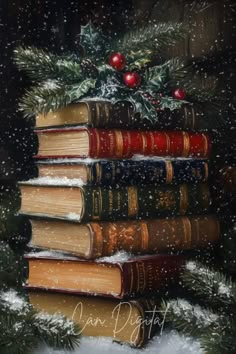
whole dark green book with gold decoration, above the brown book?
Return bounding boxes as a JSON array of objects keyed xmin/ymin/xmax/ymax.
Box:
[{"xmin": 19, "ymin": 183, "xmax": 211, "ymax": 222}]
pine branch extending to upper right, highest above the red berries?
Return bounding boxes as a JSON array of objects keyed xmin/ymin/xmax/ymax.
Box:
[{"xmin": 110, "ymin": 22, "xmax": 185, "ymax": 55}]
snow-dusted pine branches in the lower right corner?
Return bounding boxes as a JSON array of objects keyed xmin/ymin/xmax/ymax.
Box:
[{"xmin": 161, "ymin": 261, "xmax": 236, "ymax": 354}]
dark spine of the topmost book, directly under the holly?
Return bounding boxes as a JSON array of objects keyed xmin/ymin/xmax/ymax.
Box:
[{"xmin": 86, "ymin": 101, "xmax": 206, "ymax": 130}]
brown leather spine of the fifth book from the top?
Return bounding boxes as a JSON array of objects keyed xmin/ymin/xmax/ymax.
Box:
[{"xmin": 88, "ymin": 215, "xmax": 220, "ymax": 258}]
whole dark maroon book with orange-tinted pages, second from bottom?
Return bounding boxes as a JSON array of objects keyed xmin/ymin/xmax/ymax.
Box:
[{"xmin": 25, "ymin": 252, "xmax": 184, "ymax": 299}]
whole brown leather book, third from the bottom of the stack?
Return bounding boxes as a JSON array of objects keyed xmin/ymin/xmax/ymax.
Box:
[{"xmin": 28, "ymin": 215, "xmax": 220, "ymax": 259}]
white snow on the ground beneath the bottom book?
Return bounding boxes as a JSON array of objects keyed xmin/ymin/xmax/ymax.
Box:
[{"xmin": 33, "ymin": 331, "xmax": 204, "ymax": 354}]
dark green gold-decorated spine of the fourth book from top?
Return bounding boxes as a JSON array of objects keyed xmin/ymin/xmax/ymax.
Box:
[{"xmin": 82, "ymin": 183, "xmax": 210, "ymax": 221}]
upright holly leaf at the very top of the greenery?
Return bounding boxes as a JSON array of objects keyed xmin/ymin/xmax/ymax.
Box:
[{"xmin": 80, "ymin": 21, "xmax": 106, "ymax": 60}]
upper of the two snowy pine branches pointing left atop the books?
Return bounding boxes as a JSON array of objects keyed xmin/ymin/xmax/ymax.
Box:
[{"xmin": 15, "ymin": 47, "xmax": 83, "ymax": 84}]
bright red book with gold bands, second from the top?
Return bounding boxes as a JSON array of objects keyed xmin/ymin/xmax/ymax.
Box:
[{"xmin": 35, "ymin": 127, "xmax": 211, "ymax": 159}]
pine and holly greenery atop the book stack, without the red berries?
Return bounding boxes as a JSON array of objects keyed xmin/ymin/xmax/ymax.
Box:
[{"xmin": 15, "ymin": 22, "xmax": 227, "ymax": 128}]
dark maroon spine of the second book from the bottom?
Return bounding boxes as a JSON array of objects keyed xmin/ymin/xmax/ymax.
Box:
[{"xmin": 121, "ymin": 255, "xmax": 184, "ymax": 297}]
